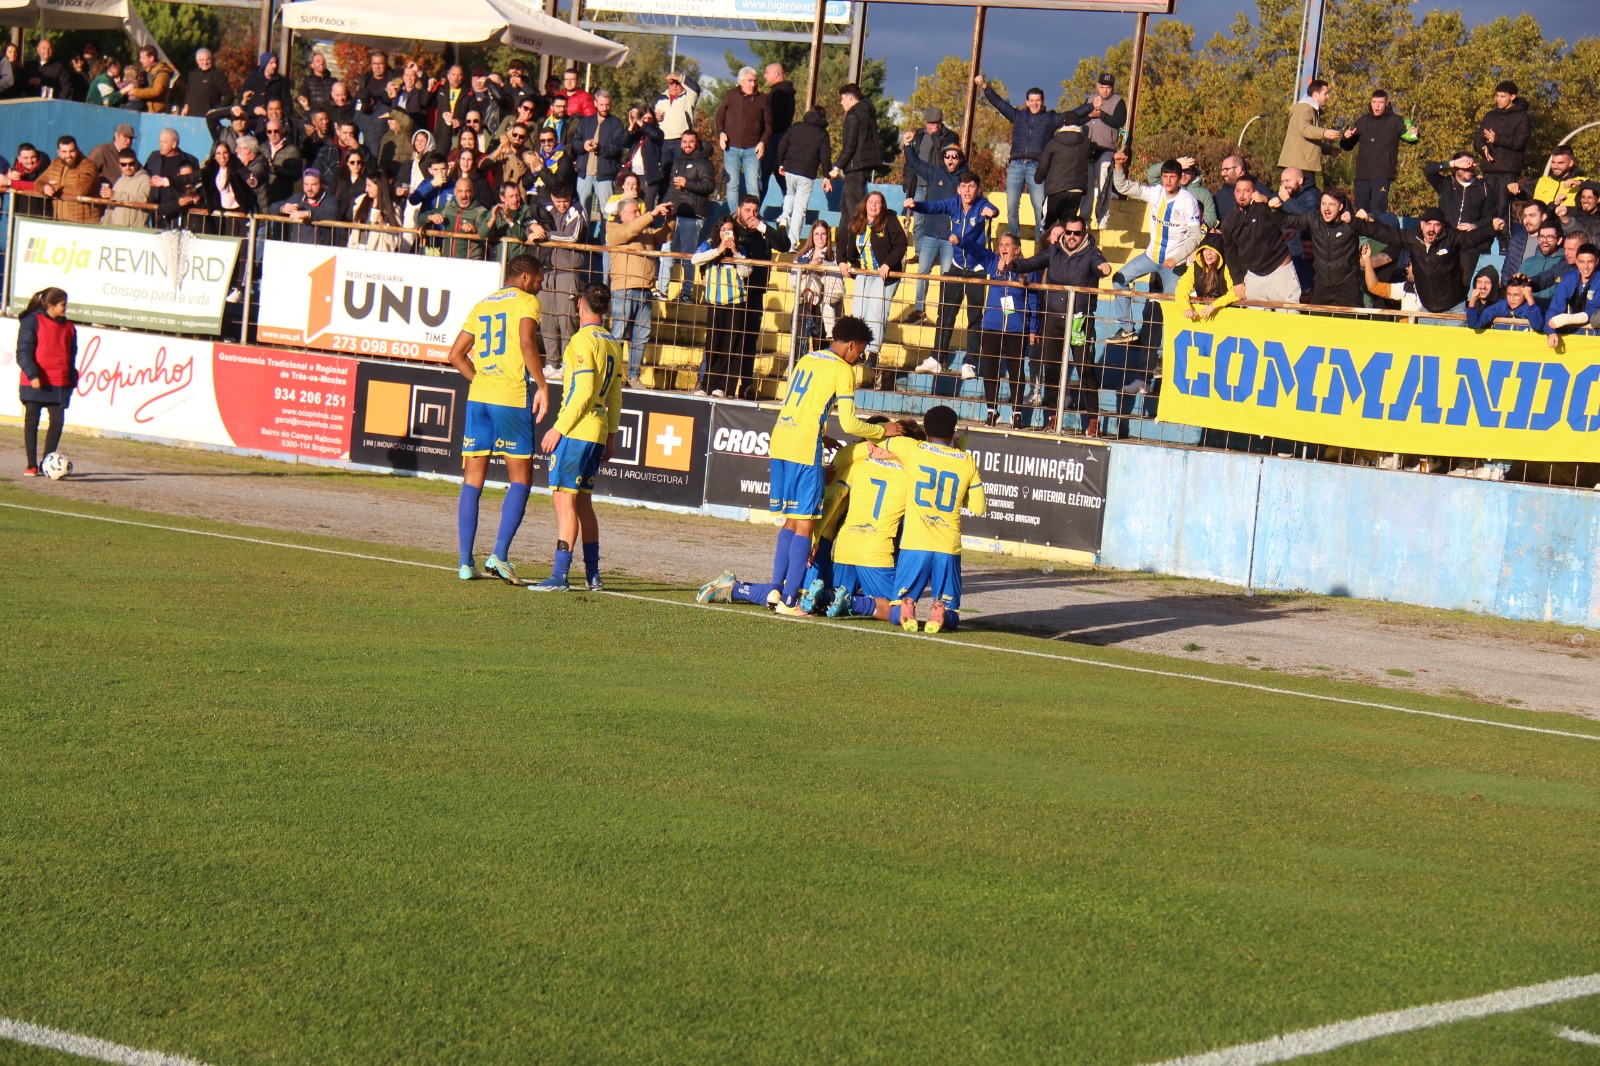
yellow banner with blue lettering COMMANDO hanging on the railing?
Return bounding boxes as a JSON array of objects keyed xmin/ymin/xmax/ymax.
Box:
[{"xmin": 1160, "ymin": 303, "xmax": 1600, "ymax": 463}]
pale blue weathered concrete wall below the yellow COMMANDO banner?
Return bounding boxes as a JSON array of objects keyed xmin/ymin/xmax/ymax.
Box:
[{"xmin": 1099, "ymin": 445, "xmax": 1600, "ymax": 627}]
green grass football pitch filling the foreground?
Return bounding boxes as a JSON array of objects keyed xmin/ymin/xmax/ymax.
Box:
[{"xmin": 0, "ymin": 493, "xmax": 1600, "ymax": 1064}]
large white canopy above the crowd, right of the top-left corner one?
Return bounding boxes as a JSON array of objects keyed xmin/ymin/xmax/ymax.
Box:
[{"xmin": 278, "ymin": 0, "xmax": 627, "ymax": 67}]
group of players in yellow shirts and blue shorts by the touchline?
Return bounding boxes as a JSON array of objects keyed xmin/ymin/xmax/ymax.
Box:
[{"xmin": 450, "ymin": 256, "xmax": 986, "ymax": 632}]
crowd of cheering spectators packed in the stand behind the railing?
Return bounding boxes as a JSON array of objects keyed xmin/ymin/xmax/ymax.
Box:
[{"xmin": 0, "ymin": 40, "xmax": 1600, "ymax": 427}]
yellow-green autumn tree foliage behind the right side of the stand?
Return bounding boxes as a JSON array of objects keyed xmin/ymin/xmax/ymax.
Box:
[{"xmin": 1061, "ymin": 0, "xmax": 1600, "ymax": 211}]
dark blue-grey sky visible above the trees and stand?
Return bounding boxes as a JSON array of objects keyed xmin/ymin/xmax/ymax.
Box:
[{"xmin": 678, "ymin": 0, "xmax": 1600, "ymax": 99}]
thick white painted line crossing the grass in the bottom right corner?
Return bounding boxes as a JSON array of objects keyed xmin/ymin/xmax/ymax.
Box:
[{"xmin": 1155, "ymin": 973, "xmax": 1600, "ymax": 1066}]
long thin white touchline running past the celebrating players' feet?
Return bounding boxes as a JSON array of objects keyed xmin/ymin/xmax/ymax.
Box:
[{"xmin": 9, "ymin": 503, "xmax": 1600, "ymax": 741}]
